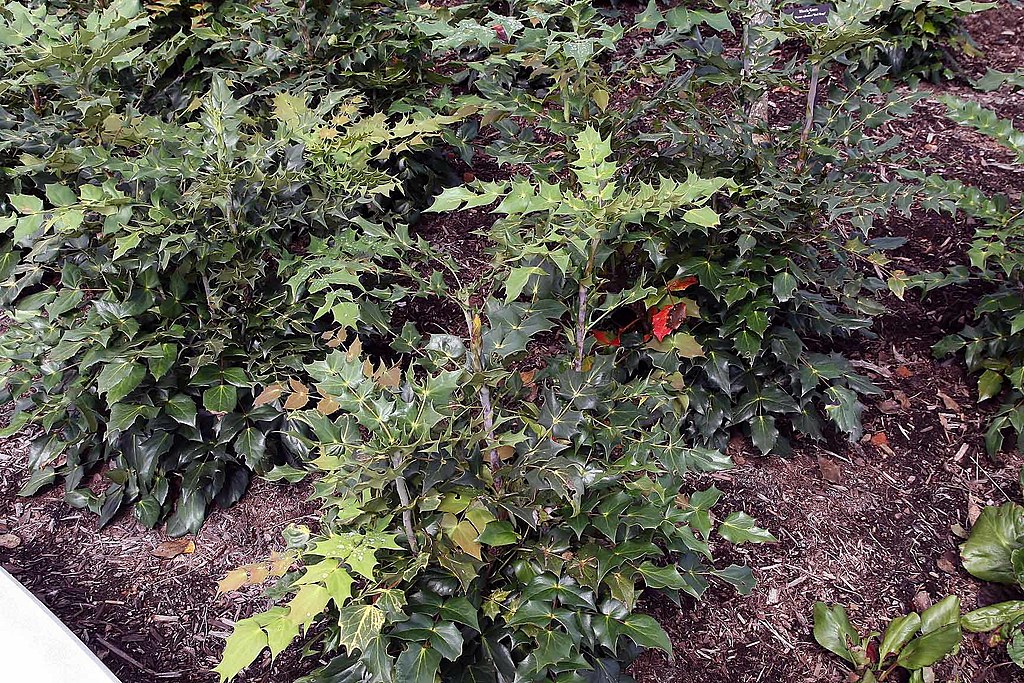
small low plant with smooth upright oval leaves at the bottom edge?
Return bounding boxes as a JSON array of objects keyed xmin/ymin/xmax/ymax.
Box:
[{"xmin": 814, "ymin": 595, "xmax": 964, "ymax": 683}]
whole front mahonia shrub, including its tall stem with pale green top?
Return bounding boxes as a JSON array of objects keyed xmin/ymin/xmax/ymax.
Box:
[{"xmin": 217, "ymin": 126, "xmax": 775, "ymax": 683}]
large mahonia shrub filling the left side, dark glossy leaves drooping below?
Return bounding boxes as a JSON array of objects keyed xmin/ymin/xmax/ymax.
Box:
[{"xmin": 0, "ymin": 2, "xmax": 453, "ymax": 535}]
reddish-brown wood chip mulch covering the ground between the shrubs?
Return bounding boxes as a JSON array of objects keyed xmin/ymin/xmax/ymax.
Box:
[{"xmin": 0, "ymin": 1, "xmax": 1024, "ymax": 683}]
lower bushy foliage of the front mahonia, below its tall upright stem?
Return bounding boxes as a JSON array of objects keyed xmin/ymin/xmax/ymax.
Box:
[{"xmin": 217, "ymin": 317, "xmax": 774, "ymax": 681}]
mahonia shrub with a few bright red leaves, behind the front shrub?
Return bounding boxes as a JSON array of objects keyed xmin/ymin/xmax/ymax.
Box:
[{"xmin": 424, "ymin": 2, "xmax": 933, "ymax": 454}]
